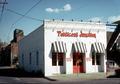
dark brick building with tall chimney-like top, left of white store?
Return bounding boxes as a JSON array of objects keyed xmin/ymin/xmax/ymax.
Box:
[{"xmin": 0, "ymin": 29, "xmax": 24, "ymax": 66}]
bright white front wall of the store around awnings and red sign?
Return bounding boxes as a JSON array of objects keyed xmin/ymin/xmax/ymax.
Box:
[{"xmin": 45, "ymin": 21, "xmax": 106, "ymax": 76}]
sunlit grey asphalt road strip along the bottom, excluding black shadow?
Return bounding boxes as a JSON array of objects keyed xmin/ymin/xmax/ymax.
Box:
[{"xmin": 0, "ymin": 76, "xmax": 120, "ymax": 84}]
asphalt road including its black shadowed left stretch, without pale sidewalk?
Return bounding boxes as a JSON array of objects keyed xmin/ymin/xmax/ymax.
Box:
[{"xmin": 0, "ymin": 67, "xmax": 120, "ymax": 84}]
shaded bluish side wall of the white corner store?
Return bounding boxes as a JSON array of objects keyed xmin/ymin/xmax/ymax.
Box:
[{"xmin": 19, "ymin": 26, "xmax": 44, "ymax": 72}]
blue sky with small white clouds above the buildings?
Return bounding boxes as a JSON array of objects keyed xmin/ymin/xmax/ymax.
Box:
[{"xmin": 0, "ymin": 0, "xmax": 120, "ymax": 42}]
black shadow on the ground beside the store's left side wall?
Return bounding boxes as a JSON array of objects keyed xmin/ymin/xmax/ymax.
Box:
[{"xmin": 0, "ymin": 67, "xmax": 57, "ymax": 81}]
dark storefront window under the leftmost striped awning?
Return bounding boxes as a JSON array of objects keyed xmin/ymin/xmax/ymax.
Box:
[{"xmin": 52, "ymin": 53, "xmax": 64, "ymax": 66}]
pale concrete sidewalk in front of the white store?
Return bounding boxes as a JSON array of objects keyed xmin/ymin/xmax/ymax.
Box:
[{"xmin": 49, "ymin": 72, "xmax": 106, "ymax": 81}]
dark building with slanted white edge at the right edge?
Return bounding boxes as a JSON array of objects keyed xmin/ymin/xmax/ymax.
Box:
[{"xmin": 107, "ymin": 21, "xmax": 120, "ymax": 66}]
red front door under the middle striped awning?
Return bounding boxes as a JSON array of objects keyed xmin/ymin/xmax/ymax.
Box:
[{"xmin": 73, "ymin": 53, "xmax": 84, "ymax": 73}]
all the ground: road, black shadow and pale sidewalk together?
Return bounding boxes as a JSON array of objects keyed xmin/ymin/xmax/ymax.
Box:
[{"xmin": 0, "ymin": 67, "xmax": 120, "ymax": 84}]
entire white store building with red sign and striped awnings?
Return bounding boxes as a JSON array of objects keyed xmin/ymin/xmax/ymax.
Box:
[{"xmin": 19, "ymin": 20, "xmax": 107, "ymax": 76}]
